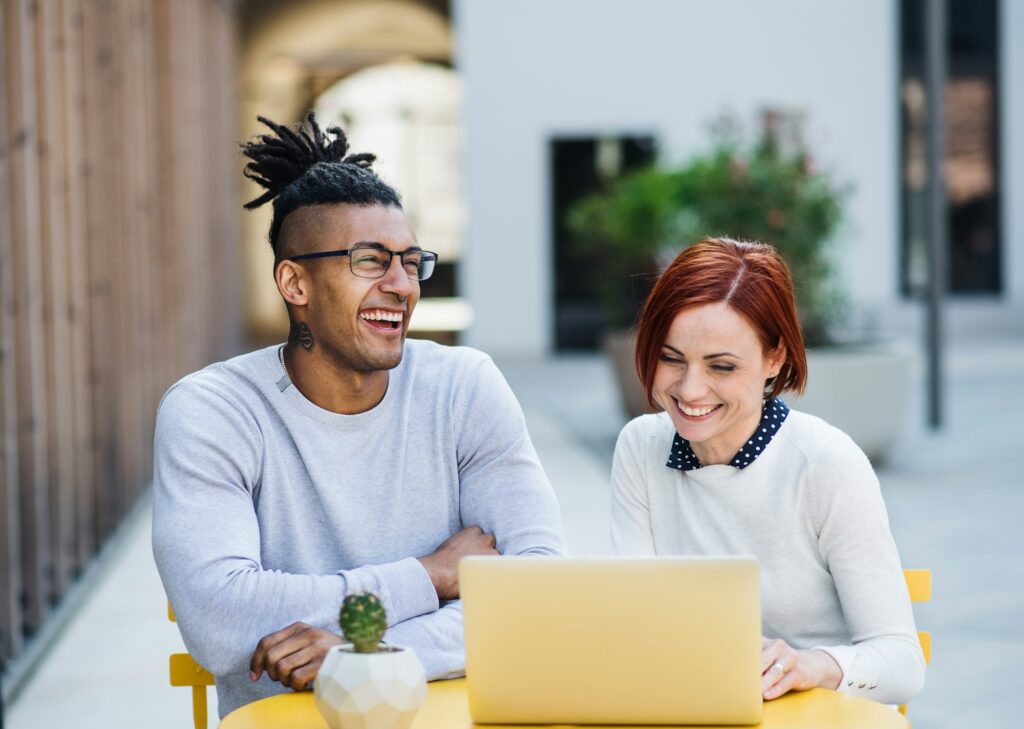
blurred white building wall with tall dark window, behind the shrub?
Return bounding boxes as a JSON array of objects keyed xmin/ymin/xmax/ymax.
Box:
[{"xmin": 453, "ymin": 0, "xmax": 1024, "ymax": 354}]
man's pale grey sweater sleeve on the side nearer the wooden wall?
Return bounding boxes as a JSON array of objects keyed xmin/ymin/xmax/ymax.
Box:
[{"xmin": 153, "ymin": 381, "xmax": 437, "ymax": 676}]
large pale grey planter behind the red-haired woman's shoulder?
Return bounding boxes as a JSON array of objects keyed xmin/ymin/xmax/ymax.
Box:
[{"xmin": 783, "ymin": 342, "xmax": 913, "ymax": 463}]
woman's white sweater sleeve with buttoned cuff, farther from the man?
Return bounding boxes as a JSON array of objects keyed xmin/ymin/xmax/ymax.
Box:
[{"xmin": 813, "ymin": 434, "xmax": 925, "ymax": 703}]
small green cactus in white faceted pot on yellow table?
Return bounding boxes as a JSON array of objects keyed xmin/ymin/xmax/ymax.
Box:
[{"xmin": 313, "ymin": 593, "xmax": 427, "ymax": 729}]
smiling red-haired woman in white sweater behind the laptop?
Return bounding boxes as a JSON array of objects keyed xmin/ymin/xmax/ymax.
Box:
[{"xmin": 611, "ymin": 239, "xmax": 925, "ymax": 703}]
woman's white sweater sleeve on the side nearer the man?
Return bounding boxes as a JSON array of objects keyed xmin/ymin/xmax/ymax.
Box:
[{"xmin": 611, "ymin": 417, "xmax": 655, "ymax": 555}]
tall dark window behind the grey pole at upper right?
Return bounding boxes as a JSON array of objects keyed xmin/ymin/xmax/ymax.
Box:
[{"xmin": 900, "ymin": 0, "xmax": 1001, "ymax": 295}]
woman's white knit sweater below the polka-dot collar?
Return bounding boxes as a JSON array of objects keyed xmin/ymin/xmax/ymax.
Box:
[{"xmin": 611, "ymin": 411, "xmax": 925, "ymax": 703}]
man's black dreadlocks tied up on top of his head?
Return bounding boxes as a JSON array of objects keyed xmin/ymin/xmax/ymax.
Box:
[{"xmin": 242, "ymin": 113, "xmax": 401, "ymax": 253}]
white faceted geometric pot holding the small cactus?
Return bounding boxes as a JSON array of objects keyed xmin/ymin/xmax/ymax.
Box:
[{"xmin": 313, "ymin": 644, "xmax": 427, "ymax": 729}]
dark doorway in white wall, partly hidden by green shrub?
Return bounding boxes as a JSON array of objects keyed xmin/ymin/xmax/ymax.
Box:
[{"xmin": 550, "ymin": 136, "xmax": 655, "ymax": 351}]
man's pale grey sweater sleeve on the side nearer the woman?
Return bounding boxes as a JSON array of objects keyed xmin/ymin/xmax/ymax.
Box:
[{"xmin": 453, "ymin": 357, "xmax": 565, "ymax": 555}]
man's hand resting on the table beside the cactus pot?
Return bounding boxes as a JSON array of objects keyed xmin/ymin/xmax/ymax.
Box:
[{"xmin": 249, "ymin": 623, "xmax": 342, "ymax": 691}]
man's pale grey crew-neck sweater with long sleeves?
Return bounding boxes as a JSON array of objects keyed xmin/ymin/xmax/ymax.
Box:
[{"xmin": 153, "ymin": 340, "xmax": 565, "ymax": 716}]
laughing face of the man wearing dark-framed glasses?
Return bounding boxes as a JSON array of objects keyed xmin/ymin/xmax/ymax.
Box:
[{"xmin": 286, "ymin": 203, "xmax": 420, "ymax": 373}]
